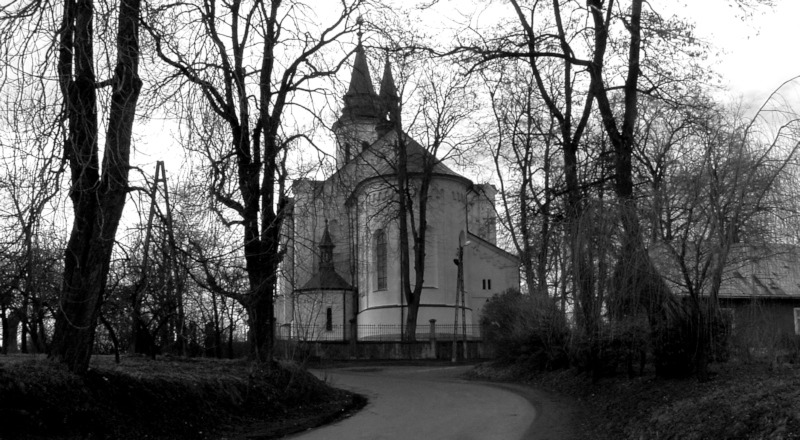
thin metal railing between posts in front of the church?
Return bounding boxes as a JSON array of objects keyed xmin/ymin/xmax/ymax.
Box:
[{"xmin": 276, "ymin": 324, "xmax": 483, "ymax": 342}]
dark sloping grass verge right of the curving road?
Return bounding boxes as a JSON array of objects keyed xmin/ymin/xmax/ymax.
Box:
[{"xmin": 471, "ymin": 361, "xmax": 800, "ymax": 440}]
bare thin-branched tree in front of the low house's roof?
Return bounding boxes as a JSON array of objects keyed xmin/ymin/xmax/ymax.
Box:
[{"xmin": 643, "ymin": 85, "xmax": 800, "ymax": 380}]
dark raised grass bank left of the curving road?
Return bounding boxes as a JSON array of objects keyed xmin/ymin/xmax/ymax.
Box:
[{"xmin": 0, "ymin": 355, "xmax": 366, "ymax": 439}]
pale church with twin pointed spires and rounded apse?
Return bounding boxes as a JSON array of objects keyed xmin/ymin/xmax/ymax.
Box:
[{"xmin": 275, "ymin": 43, "xmax": 519, "ymax": 340}]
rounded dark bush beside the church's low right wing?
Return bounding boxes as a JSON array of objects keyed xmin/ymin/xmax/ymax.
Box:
[{"xmin": 481, "ymin": 290, "xmax": 569, "ymax": 370}]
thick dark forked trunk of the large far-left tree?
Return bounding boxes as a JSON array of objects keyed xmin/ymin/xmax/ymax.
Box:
[{"xmin": 50, "ymin": 0, "xmax": 142, "ymax": 373}]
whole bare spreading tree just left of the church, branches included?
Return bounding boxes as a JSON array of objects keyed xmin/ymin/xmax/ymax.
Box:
[{"xmin": 142, "ymin": 0, "xmax": 365, "ymax": 361}]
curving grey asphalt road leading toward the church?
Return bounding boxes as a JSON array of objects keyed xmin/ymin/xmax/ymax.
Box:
[{"xmin": 288, "ymin": 366, "xmax": 571, "ymax": 440}]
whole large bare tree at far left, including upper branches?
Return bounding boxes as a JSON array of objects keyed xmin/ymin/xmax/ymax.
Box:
[{"xmin": 0, "ymin": 0, "xmax": 141, "ymax": 373}]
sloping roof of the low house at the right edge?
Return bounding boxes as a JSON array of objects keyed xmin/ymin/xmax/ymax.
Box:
[{"xmin": 650, "ymin": 244, "xmax": 800, "ymax": 298}]
